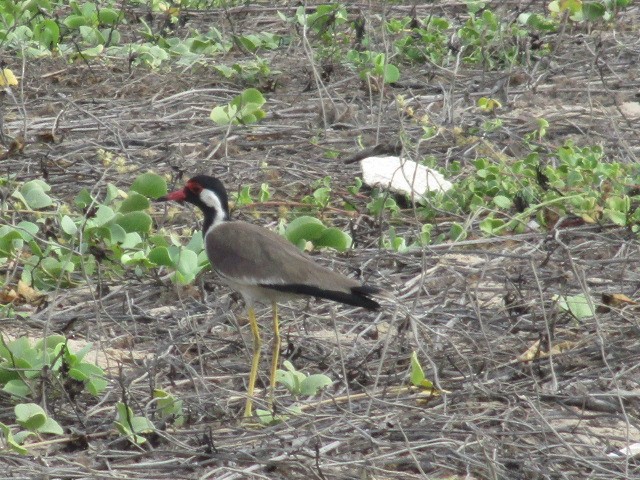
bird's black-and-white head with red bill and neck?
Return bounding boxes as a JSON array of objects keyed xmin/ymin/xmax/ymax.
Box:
[{"xmin": 158, "ymin": 175, "xmax": 229, "ymax": 232}]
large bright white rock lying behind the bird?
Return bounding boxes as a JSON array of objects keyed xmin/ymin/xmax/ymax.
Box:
[{"xmin": 360, "ymin": 157, "xmax": 453, "ymax": 200}]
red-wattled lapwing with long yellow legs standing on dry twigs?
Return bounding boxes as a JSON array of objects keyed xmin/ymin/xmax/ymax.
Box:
[{"xmin": 159, "ymin": 175, "xmax": 380, "ymax": 417}]
